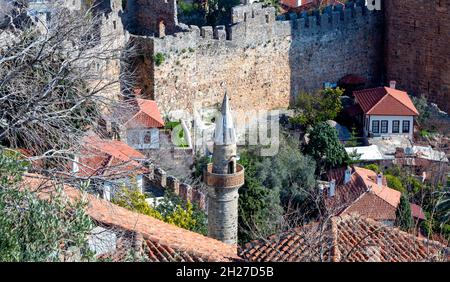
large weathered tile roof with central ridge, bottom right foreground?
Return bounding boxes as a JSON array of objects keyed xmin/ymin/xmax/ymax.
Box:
[{"xmin": 240, "ymin": 214, "xmax": 450, "ymax": 262}]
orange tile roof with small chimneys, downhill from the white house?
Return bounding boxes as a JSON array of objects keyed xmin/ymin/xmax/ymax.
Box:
[{"xmin": 323, "ymin": 167, "xmax": 401, "ymax": 220}]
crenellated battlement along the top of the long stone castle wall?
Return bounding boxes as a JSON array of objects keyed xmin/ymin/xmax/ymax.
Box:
[{"xmin": 147, "ymin": 0, "xmax": 382, "ymax": 50}]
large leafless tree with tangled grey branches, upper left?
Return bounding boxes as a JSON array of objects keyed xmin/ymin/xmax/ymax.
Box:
[{"xmin": 0, "ymin": 1, "xmax": 133, "ymax": 174}]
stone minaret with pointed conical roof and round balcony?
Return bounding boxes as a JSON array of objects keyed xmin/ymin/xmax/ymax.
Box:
[{"xmin": 205, "ymin": 93, "xmax": 244, "ymax": 244}]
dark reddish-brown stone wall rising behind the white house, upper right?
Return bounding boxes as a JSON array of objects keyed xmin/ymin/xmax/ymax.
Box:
[{"xmin": 384, "ymin": 0, "xmax": 450, "ymax": 112}]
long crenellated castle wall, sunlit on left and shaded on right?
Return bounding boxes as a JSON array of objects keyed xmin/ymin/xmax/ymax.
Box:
[{"xmin": 130, "ymin": 1, "xmax": 383, "ymax": 117}]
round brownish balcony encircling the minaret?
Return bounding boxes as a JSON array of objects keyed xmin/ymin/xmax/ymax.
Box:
[{"xmin": 204, "ymin": 163, "xmax": 244, "ymax": 188}]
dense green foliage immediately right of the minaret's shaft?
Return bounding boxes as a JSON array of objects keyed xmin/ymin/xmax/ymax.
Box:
[{"xmin": 239, "ymin": 133, "xmax": 315, "ymax": 243}]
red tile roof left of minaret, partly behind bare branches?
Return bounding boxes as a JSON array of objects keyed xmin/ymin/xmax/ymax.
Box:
[{"xmin": 77, "ymin": 136, "xmax": 146, "ymax": 177}]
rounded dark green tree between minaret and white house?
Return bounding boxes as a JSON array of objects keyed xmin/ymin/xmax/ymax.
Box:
[{"xmin": 305, "ymin": 122, "xmax": 348, "ymax": 174}]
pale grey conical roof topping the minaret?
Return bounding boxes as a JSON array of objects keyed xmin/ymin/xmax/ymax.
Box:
[{"xmin": 214, "ymin": 91, "xmax": 236, "ymax": 145}]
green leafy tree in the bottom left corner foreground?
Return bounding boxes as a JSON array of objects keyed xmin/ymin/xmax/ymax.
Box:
[{"xmin": 0, "ymin": 150, "xmax": 94, "ymax": 262}]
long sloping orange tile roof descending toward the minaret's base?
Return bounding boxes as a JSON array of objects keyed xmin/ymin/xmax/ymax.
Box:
[{"xmin": 23, "ymin": 173, "xmax": 239, "ymax": 261}]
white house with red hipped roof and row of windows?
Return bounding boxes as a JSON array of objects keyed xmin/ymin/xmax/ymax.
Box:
[{"xmin": 353, "ymin": 82, "xmax": 419, "ymax": 139}]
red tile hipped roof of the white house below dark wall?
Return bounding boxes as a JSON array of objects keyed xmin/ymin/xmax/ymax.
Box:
[{"xmin": 353, "ymin": 87, "xmax": 419, "ymax": 116}]
